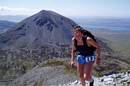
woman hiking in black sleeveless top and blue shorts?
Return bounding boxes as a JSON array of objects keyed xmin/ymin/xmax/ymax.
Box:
[{"xmin": 71, "ymin": 26, "xmax": 100, "ymax": 86}]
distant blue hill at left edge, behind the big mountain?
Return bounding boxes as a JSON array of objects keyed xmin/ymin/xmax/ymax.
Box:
[{"xmin": 0, "ymin": 20, "xmax": 15, "ymax": 33}]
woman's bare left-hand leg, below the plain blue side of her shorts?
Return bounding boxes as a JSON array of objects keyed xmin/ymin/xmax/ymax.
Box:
[{"xmin": 77, "ymin": 63, "xmax": 85, "ymax": 86}]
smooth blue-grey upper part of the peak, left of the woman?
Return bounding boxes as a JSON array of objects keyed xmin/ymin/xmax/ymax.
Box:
[{"xmin": 0, "ymin": 10, "xmax": 76, "ymax": 48}]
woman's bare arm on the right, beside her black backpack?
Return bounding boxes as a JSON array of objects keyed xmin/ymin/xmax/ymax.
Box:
[{"xmin": 86, "ymin": 37, "xmax": 101, "ymax": 58}]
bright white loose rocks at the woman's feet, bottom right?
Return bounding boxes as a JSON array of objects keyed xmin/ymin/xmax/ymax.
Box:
[{"xmin": 59, "ymin": 73, "xmax": 130, "ymax": 86}]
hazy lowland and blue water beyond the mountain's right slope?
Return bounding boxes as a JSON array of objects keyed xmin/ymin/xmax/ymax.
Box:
[{"xmin": 73, "ymin": 18, "xmax": 130, "ymax": 58}]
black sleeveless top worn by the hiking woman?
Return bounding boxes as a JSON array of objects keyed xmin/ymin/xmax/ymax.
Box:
[{"xmin": 74, "ymin": 36, "xmax": 95, "ymax": 56}]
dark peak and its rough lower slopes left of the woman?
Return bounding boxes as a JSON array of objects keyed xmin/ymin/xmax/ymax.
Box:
[{"xmin": 0, "ymin": 10, "xmax": 77, "ymax": 81}]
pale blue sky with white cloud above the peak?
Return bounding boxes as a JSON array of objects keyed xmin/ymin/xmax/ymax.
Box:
[{"xmin": 0, "ymin": 0, "xmax": 130, "ymax": 17}]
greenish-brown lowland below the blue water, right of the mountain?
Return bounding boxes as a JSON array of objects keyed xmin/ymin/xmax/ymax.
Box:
[{"xmin": 86, "ymin": 29, "xmax": 130, "ymax": 56}]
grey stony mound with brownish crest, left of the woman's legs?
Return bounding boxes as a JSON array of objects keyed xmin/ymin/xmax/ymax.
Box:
[{"xmin": 11, "ymin": 60, "xmax": 77, "ymax": 86}]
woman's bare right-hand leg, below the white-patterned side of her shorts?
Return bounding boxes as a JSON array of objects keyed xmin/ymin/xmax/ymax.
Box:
[{"xmin": 84, "ymin": 62, "xmax": 94, "ymax": 81}]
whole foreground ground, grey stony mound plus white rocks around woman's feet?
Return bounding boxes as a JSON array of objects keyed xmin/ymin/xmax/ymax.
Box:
[{"xmin": 8, "ymin": 59, "xmax": 130, "ymax": 86}]
